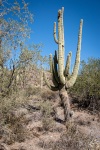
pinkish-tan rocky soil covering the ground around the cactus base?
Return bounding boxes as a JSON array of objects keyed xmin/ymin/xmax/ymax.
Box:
[{"xmin": 0, "ymin": 91, "xmax": 100, "ymax": 150}]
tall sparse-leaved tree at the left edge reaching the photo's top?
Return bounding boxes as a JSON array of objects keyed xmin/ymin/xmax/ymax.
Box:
[{"xmin": 0, "ymin": 0, "xmax": 33, "ymax": 96}]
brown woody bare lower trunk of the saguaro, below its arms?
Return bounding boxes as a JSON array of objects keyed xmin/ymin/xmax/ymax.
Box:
[{"xmin": 59, "ymin": 86, "xmax": 72, "ymax": 122}]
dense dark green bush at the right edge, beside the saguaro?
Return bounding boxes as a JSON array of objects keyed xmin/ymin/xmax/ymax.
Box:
[{"xmin": 70, "ymin": 58, "xmax": 100, "ymax": 110}]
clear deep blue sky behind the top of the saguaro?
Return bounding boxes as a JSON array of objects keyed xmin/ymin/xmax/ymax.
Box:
[{"xmin": 8, "ymin": 0, "xmax": 100, "ymax": 64}]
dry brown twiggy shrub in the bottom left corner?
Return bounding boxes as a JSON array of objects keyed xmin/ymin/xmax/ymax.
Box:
[{"xmin": 2, "ymin": 113, "xmax": 28, "ymax": 144}]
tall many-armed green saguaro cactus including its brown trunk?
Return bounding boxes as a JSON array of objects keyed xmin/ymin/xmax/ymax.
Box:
[{"xmin": 44, "ymin": 7, "xmax": 83, "ymax": 121}]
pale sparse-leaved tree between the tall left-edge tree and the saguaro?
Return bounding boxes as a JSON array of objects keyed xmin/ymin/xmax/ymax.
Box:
[{"xmin": 16, "ymin": 44, "xmax": 48, "ymax": 88}]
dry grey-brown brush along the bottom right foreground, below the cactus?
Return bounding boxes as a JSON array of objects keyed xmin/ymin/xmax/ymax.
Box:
[{"xmin": 38, "ymin": 122, "xmax": 100, "ymax": 150}]
